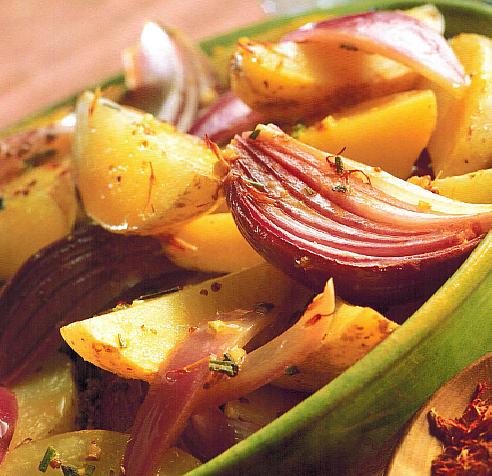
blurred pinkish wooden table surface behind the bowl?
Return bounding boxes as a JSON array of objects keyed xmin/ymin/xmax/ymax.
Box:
[{"xmin": 0, "ymin": 0, "xmax": 265, "ymax": 128}]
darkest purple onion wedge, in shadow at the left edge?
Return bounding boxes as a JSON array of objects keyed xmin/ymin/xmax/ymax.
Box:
[{"xmin": 0, "ymin": 226, "xmax": 189, "ymax": 385}]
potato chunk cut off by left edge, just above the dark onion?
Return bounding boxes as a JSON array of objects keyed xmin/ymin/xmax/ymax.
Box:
[{"xmin": 0, "ymin": 157, "xmax": 77, "ymax": 281}]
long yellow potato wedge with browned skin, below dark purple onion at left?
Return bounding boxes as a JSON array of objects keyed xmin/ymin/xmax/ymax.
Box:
[{"xmin": 60, "ymin": 264, "xmax": 310, "ymax": 381}]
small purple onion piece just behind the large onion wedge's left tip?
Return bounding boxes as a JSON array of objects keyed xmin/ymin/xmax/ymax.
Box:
[{"xmin": 188, "ymin": 91, "xmax": 264, "ymax": 145}]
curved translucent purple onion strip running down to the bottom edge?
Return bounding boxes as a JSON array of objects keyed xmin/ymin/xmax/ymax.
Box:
[{"xmin": 125, "ymin": 311, "xmax": 267, "ymax": 476}]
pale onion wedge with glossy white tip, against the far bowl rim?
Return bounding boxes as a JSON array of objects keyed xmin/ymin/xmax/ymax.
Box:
[{"xmin": 123, "ymin": 22, "xmax": 216, "ymax": 132}]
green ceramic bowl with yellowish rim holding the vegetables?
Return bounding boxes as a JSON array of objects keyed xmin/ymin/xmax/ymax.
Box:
[{"xmin": 4, "ymin": 0, "xmax": 492, "ymax": 476}]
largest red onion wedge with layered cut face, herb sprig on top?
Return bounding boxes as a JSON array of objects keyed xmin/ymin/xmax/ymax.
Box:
[{"xmin": 224, "ymin": 125, "xmax": 492, "ymax": 305}]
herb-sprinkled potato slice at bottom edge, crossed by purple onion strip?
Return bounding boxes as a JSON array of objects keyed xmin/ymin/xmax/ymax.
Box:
[{"xmin": 0, "ymin": 430, "xmax": 200, "ymax": 476}]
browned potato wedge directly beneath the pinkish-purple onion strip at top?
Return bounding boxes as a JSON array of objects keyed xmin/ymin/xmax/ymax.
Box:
[{"xmin": 231, "ymin": 39, "xmax": 418, "ymax": 122}]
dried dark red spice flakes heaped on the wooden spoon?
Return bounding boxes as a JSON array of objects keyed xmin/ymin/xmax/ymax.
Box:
[{"xmin": 427, "ymin": 383, "xmax": 492, "ymax": 476}]
